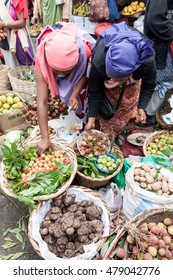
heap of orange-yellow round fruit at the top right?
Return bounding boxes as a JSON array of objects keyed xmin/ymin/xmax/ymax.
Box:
[{"xmin": 121, "ymin": 1, "xmax": 145, "ymax": 18}]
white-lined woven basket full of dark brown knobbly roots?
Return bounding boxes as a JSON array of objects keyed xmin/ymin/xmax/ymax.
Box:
[{"xmin": 28, "ymin": 186, "xmax": 110, "ymax": 260}]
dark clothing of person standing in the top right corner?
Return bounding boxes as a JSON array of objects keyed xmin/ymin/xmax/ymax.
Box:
[{"xmin": 144, "ymin": 0, "xmax": 173, "ymax": 69}]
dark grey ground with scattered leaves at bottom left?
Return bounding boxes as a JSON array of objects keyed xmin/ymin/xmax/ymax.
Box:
[{"xmin": 0, "ymin": 133, "xmax": 42, "ymax": 260}]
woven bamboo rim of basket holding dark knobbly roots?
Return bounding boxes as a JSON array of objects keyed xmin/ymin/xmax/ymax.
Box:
[{"xmin": 28, "ymin": 185, "xmax": 110, "ymax": 257}]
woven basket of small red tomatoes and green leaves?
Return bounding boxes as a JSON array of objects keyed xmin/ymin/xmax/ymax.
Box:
[{"xmin": 0, "ymin": 137, "xmax": 77, "ymax": 208}]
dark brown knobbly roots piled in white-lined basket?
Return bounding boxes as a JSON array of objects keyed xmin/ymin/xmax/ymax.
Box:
[{"xmin": 40, "ymin": 192, "xmax": 104, "ymax": 258}]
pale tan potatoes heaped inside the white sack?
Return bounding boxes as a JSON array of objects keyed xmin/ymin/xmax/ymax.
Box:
[{"xmin": 134, "ymin": 163, "xmax": 173, "ymax": 197}]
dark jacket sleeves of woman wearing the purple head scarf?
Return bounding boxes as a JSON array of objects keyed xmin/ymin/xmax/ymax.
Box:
[{"xmin": 88, "ymin": 37, "xmax": 156, "ymax": 117}]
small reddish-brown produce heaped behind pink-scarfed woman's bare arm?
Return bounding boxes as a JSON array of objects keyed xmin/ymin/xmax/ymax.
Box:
[{"xmin": 25, "ymin": 96, "xmax": 67, "ymax": 125}]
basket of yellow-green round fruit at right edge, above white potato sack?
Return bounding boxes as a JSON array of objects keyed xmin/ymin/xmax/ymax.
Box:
[{"xmin": 143, "ymin": 130, "xmax": 173, "ymax": 157}]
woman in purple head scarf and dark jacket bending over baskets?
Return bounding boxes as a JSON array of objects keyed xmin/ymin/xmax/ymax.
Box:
[{"xmin": 85, "ymin": 22, "xmax": 156, "ymax": 139}]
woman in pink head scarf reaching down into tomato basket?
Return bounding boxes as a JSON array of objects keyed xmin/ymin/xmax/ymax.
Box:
[{"xmin": 35, "ymin": 22, "xmax": 95, "ymax": 153}]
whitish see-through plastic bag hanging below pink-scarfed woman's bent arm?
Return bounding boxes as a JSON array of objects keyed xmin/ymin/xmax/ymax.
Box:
[{"xmin": 57, "ymin": 111, "xmax": 83, "ymax": 143}]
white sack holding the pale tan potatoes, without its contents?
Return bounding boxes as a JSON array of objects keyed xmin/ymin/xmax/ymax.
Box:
[{"xmin": 123, "ymin": 163, "xmax": 173, "ymax": 220}]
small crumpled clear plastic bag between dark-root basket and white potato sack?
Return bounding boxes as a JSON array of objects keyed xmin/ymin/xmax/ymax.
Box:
[{"xmin": 100, "ymin": 183, "xmax": 123, "ymax": 212}]
